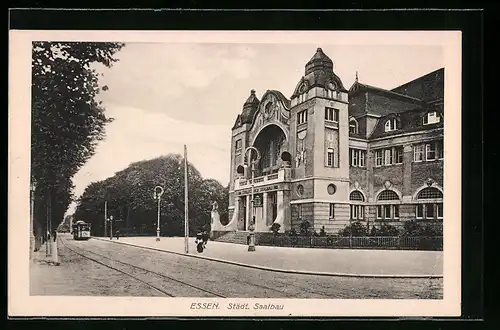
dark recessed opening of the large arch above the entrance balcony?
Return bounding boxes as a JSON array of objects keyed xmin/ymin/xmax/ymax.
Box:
[{"xmin": 253, "ymin": 125, "xmax": 287, "ymax": 176}]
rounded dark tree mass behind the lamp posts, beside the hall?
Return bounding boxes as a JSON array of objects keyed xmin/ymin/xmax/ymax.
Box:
[{"xmin": 74, "ymin": 154, "xmax": 229, "ymax": 236}]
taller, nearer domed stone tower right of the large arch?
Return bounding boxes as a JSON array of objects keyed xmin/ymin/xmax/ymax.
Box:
[{"xmin": 290, "ymin": 48, "xmax": 349, "ymax": 232}]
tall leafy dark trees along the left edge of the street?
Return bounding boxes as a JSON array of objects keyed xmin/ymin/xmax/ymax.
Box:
[{"xmin": 31, "ymin": 42, "xmax": 124, "ymax": 245}]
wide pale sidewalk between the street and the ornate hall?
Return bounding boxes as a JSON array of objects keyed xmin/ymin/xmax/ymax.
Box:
[{"xmin": 94, "ymin": 237, "xmax": 443, "ymax": 278}]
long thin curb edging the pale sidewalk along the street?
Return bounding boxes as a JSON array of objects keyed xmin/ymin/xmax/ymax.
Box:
[{"xmin": 92, "ymin": 237, "xmax": 443, "ymax": 279}]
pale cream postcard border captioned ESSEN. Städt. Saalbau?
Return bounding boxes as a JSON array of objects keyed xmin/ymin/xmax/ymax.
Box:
[{"xmin": 8, "ymin": 30, "xmax": 461, "ymax": 317}]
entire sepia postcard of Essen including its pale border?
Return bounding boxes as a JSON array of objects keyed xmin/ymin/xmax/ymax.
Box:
[{"xmin": 9, "ymin": 31, "xmax": 461, "ymax": 316}]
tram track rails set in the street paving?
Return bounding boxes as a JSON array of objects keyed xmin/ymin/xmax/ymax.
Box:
[{"xmin": 60, "ymin": 239, "xmax": 226, "ymax": 298}]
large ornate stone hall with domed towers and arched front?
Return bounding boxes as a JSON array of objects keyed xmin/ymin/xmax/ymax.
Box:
[{"xmin": 217, "ymin": 48, "xmax": 444, "ymax": 233}]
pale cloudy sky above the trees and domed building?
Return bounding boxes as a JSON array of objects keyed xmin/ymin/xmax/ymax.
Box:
[{"xmin": 67, "ymin": 42, "xmax": 444, "ymax": 214}]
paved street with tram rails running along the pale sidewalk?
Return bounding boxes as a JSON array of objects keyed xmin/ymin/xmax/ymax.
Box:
[{"xmin": 31, "ymin": 235, "xmax": 443, "ymax": 299}]
